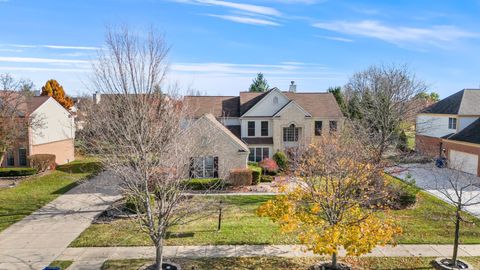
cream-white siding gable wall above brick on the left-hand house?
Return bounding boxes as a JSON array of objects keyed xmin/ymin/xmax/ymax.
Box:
[{"xmin": 32, "ymin": 98, "xmax": 75, "ymax": 145}]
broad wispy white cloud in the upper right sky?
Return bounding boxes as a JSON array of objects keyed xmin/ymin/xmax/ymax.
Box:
[{"xmin": 313, "ymin": 20, "xmax": 479, "ymax": 47}]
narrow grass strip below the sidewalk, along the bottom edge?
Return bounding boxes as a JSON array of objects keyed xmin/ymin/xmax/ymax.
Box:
[{"xmin": 102, "ymin": 257, "xmax": 480, "ymax": 270}]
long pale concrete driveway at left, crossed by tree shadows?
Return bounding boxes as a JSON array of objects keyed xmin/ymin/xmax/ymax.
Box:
[{"xmin": 0, "ymin": 173, "xmax": 120, "ymax": 270}]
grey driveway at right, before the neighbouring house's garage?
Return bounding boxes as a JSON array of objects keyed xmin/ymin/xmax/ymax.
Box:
[{"xmin": 387, "ymin": 164, "xmax": 480, "ymax": 218}]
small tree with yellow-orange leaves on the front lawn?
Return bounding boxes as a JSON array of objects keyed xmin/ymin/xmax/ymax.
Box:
[{"xmin": 257, "ymin": 131, "xmax": 401, "ymax": 269}]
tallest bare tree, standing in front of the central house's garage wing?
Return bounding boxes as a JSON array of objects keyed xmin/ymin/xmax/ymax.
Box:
[{"xmin": 84, "ymin": 25, "xmax": 216, "ymax": 269}]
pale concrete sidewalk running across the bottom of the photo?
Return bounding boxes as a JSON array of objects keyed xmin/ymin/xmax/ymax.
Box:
[{"xmin": 60, "ymin": 245, "xmax": 480, "ymax": 270}]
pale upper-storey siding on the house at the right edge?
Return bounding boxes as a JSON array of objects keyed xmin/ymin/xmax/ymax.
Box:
[{"xmin": 416, "ymin": 115, "xmax": 458, "ymax": 138}]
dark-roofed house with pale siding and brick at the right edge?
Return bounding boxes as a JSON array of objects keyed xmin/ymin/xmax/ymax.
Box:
[{"xmin": 415, "ymin": 89, "xmax": 480, "ymax": 175}]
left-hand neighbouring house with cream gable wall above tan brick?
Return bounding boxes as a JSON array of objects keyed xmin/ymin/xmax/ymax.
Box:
[{"xmin": 0, "ymin": 96, "xmax": 75, "ymax": 167}]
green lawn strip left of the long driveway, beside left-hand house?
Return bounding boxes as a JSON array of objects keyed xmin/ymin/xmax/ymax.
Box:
[{"xmin": 0, "ymin": 159, "xmax": 100, "ymax": 231}]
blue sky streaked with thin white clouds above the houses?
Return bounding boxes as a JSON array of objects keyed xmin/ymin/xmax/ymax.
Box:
[{"xmin": 0, "ymin": 0, "xmax": 480, "ymax": 97}]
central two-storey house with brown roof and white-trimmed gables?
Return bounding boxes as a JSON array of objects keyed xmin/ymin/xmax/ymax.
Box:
[{"xmin": 185, "ymin": 84, "xmax": 344, "ymax": 178}]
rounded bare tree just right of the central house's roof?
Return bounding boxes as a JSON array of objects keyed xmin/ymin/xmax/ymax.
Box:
[{"xmin": 345, "ymin": 65, "xmax": 427, "ymax": 161}]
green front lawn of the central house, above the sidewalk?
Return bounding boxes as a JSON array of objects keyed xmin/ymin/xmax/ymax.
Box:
[{"xmin": 71, "ymin": 179, "xmax": 480, "ymax": 247}]
